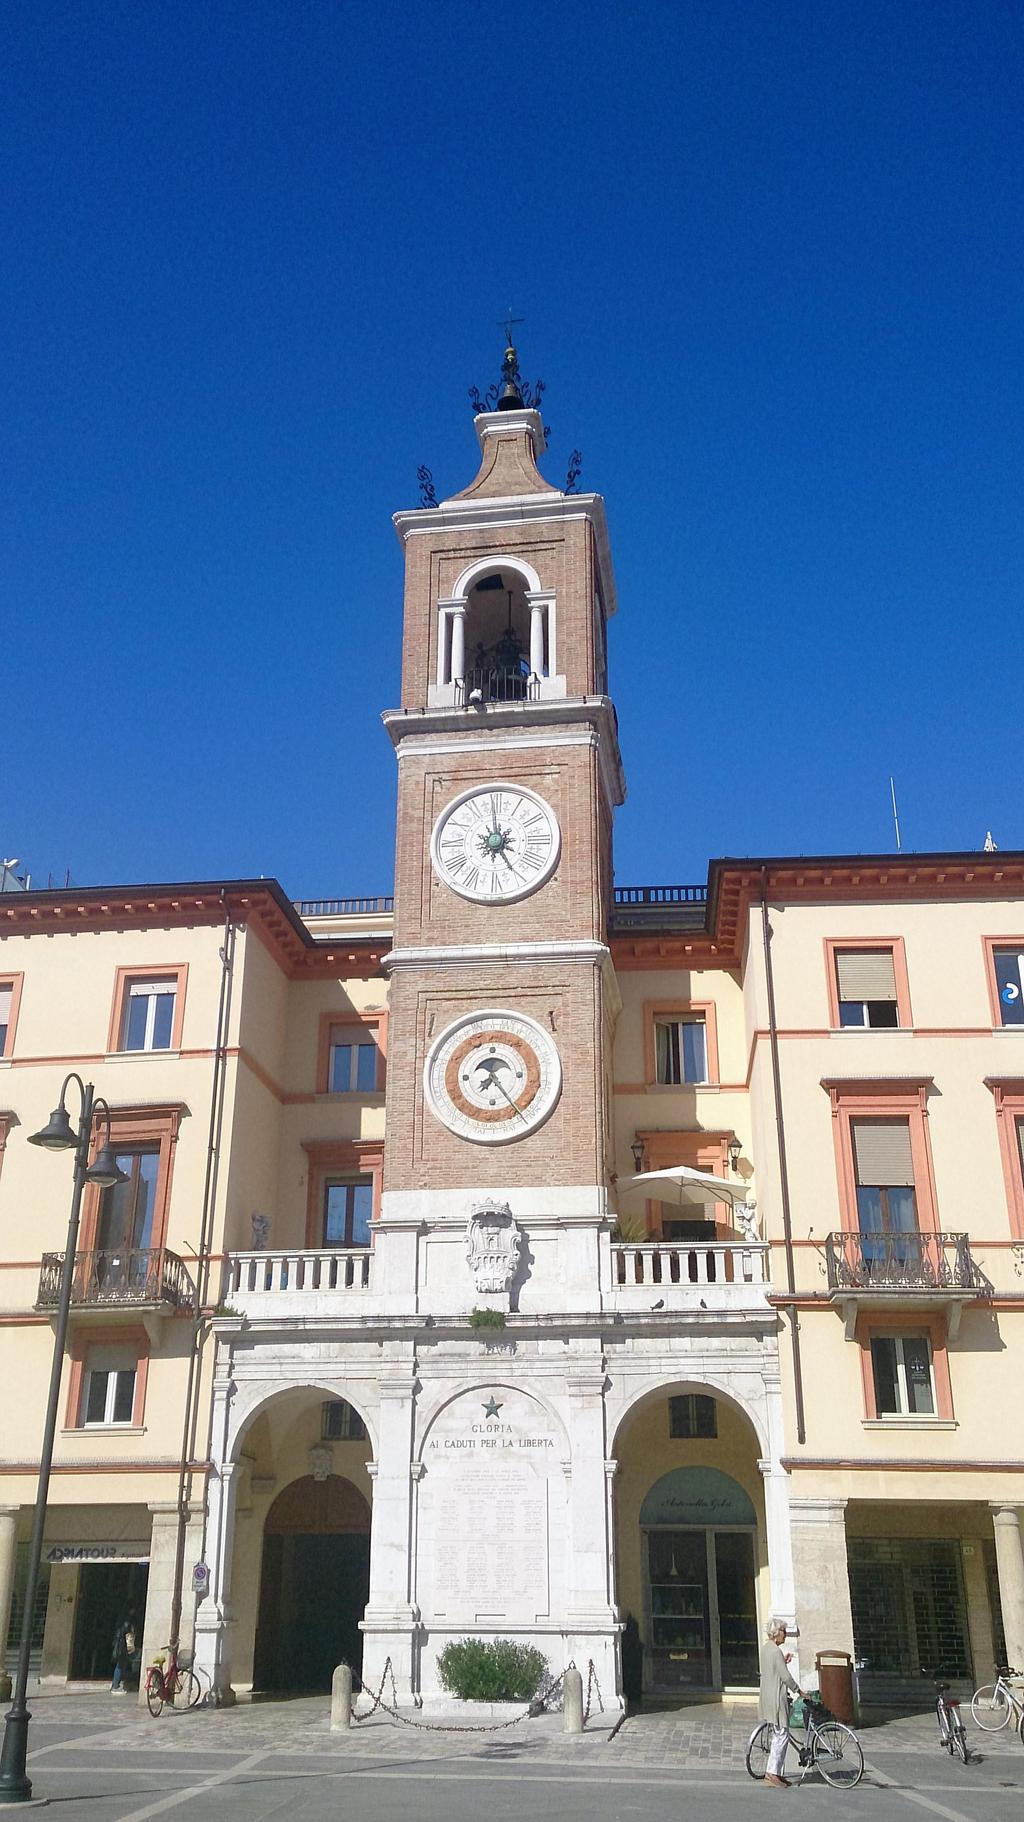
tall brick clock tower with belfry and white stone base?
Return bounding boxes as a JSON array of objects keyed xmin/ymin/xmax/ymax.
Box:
[{"xmin": 363, "ymin": 350, "xmax": 623, "ymax": 1691}]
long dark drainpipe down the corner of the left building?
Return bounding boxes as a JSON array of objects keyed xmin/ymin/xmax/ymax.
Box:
[{"xmin": 168, "ymin": 893, "xmax": 235, "ymax": 1651}]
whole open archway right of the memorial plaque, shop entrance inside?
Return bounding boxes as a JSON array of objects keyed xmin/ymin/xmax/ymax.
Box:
[{"xmin": 616, "ymin": 1390, "xmax": 769, "ymax": 1704}]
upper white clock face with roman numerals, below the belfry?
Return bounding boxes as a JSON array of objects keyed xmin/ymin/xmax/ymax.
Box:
[{"xmin": 430, "ymin": 783, "xmax": 561, "ymax": 904}]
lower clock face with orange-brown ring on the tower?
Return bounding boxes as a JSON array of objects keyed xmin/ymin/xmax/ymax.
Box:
[{"xmin": 423, "ymin": 1011, "xmax": 561, "ymax": 1144}]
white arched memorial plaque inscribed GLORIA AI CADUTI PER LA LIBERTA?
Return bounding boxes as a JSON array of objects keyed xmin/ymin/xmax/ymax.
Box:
[{"xmin": 417, "ymin": 1387, "xmax": 565, "ymax": 1625}]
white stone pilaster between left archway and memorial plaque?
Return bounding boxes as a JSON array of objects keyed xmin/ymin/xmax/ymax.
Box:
[{"xmin": 359, "ymin": 1361, "xmax": 419, "ymax": 1700}]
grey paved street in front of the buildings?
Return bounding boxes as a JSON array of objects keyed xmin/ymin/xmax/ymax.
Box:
[{"xmin": 11, "ymin": 1694, "xmax": 1024, "ymax": 1822}]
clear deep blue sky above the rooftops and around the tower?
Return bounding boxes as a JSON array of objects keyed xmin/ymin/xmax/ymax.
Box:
[{"xmin": 0, "ymin": 0, "xmax": 1024, "ymax": 896}]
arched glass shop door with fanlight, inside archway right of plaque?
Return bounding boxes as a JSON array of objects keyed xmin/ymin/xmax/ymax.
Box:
[{"xmin": 640, "ymin": 1469, "xmax": 758, "ymax": 1694}]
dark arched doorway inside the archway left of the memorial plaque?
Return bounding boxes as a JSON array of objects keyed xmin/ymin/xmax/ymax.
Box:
[{"xmin": 253, "ymin": 1474, "xmax": 370, "ymax": 1693}]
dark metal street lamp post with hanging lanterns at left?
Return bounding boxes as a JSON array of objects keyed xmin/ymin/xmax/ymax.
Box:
[{"xmin": 0, "ymin": 1073, "xmax": 128, "ymax": 1804}]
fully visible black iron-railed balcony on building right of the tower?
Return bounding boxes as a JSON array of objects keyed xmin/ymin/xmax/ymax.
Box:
[{"xmin": 825, "ymin": 1233, "xmax": 989, "ymax": 1336}]
